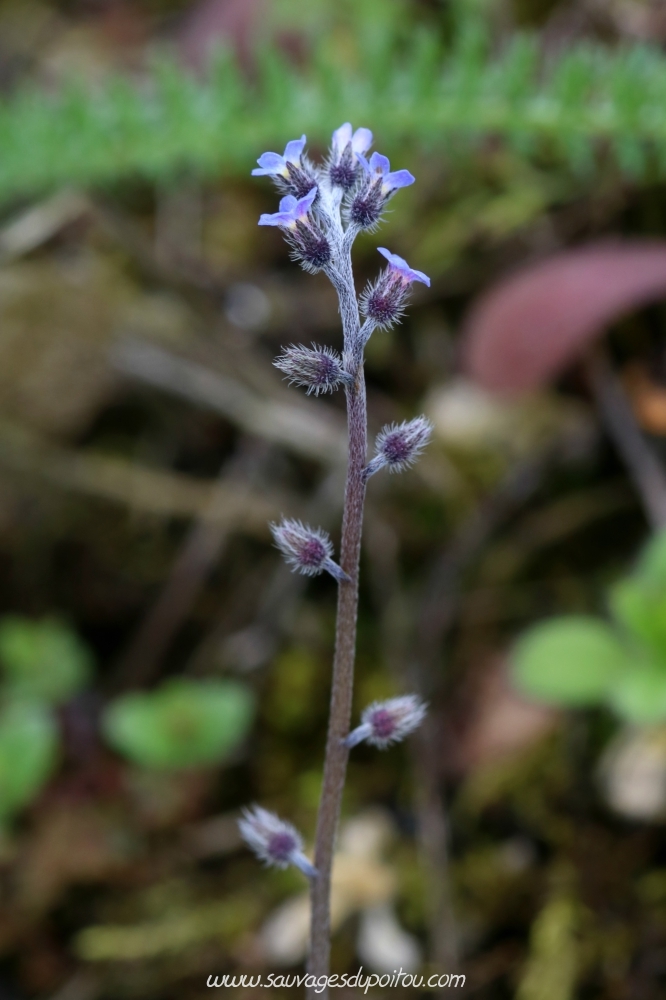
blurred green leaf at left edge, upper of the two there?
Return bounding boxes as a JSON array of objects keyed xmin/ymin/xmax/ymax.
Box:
[{"xmin": 0, "ymin": 615, "xmax": 93, "ymax": 704}]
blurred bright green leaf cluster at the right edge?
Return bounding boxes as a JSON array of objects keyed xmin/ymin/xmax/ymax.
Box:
[{"xmin": 512, "ymin": 531, "xmax": 666, "ymax": 724}]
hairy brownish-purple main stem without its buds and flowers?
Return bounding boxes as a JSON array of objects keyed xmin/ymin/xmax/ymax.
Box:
[{"xmin": 308, "ymin": 254, "xmax": 367, "ymax": 1000}]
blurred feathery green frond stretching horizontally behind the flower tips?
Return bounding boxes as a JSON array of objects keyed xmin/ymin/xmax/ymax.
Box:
[{"xmin": 0, "ymin": 10, "xmax": 666, "ymax": 201}]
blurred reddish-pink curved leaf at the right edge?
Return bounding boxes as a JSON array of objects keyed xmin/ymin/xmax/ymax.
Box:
[{"xmin": 463, "ymin": 241, "xmax": 666, "ymax": 394}]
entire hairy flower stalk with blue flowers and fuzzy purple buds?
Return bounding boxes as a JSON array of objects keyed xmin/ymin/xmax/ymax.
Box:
[{"xmin": 241, "ymin": 123, "xmax": 431, "ymax": 1000}]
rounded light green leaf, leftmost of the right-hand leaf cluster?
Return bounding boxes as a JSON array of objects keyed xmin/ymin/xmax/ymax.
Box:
[{"xmin": 512, "ymin": 615, "xmax": 627, "ymax": 705}]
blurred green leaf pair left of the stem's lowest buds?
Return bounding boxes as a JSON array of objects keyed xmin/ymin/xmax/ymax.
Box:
[{"xmin": 103, "ymin": 679, "xmax": 254, "ymax": 770}]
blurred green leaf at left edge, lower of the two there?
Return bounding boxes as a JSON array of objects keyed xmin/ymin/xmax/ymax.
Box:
[{"xmin": 0, "ymin": 702, "xmax": 58, "ymax": 819}]
